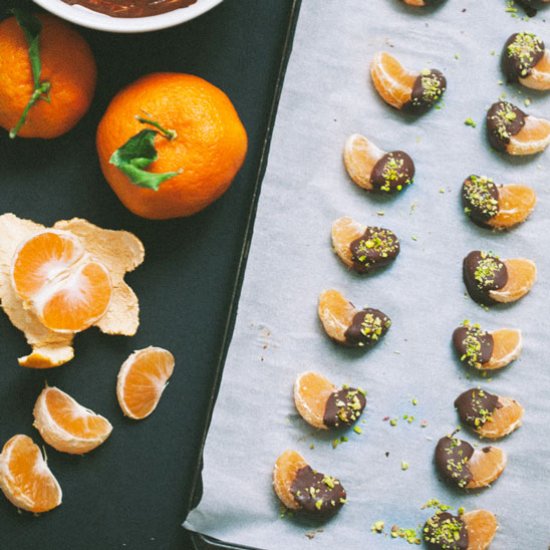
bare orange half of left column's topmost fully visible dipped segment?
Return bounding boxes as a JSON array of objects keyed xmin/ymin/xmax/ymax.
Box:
[{"xmin": 371, "ymin": 52, "xmax": 418, "ymax": 109}]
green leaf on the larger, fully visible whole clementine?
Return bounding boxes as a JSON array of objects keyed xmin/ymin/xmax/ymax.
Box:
[{"xmin": 109, "ymin": 129, "xmax": 181, "ymax": 191}]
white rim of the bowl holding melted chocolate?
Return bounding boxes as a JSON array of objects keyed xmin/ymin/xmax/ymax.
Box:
[{"xmin": 34, "ymin": 0, "xmax": 223, "ymax": 33}]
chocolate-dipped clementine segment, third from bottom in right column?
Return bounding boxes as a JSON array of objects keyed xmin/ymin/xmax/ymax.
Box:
[{"xmin": 455, "ymin": 388, "xmax": 524, "ymax": 439}]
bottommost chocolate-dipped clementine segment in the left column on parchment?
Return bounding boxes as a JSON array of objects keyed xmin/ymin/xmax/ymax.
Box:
[{"xmin": 273, "ymin": 450, "xmax": 346, "ymax": 518}]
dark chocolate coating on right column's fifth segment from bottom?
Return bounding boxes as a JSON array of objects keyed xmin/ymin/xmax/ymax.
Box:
[{"xmin": 463, "ymin": 250, "xmax": 508, "ymax": 305}]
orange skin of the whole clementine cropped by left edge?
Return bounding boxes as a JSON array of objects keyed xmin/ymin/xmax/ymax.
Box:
[{"xmin": 0, "ymin": 14, "xmax": 97, "ymax": 139}]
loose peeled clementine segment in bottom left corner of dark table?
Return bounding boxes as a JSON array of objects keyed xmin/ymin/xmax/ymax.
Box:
[{"xmin": 0, "ymin": 435, "xmax": 62, "ymax": 513}]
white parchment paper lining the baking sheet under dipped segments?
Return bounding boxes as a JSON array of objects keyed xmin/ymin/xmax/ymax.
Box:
[{"xmin": 185, "ymin": 0, "xmax": 550, "ymax": 550}]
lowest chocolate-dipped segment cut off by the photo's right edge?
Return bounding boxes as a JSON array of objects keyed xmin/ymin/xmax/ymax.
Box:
[{"xmin": 487, "ymin": 101, "xmax": 550, "ymax": 155}]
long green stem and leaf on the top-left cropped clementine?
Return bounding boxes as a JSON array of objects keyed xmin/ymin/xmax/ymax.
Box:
[{"xmin": 10, "ymin": 8, "xmax": 51, "ymax": 139}]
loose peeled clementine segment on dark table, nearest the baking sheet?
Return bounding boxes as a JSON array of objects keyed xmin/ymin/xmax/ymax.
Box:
[{"xmin": 116, "ymin": 346, "xmax": 175, "ymax": 420}]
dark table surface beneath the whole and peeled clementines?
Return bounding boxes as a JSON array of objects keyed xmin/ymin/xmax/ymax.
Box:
[{"xmin": 0, "ymin": 0, "xmax": 293, "ymax": 550}]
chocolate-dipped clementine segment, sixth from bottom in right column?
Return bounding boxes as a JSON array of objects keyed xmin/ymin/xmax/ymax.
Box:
[{"xmin": 462, "ymin": 175, "xmax": 537, "ymax": 229}]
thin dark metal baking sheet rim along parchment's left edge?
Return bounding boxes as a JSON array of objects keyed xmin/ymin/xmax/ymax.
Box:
[{"xmin": 187, "ymin": 0, "xmax": 302, "ymax": 550}]
